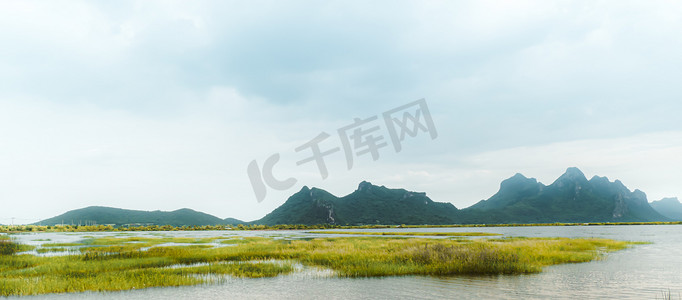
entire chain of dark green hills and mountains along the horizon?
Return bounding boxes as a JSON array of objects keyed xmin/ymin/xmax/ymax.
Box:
[{"xmin": 35, "ymin": 168, "xmax": 668, "ymax": 226}]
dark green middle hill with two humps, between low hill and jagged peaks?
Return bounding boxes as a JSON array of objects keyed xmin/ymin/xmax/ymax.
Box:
[{"xmin": 253, "ymin": 181, "xmax": 457, "ymax": 225}]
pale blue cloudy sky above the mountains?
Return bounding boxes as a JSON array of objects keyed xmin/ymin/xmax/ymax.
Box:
[{"xmin": 0, "ymin": 0, "xmax": 682, "ymax": 224}]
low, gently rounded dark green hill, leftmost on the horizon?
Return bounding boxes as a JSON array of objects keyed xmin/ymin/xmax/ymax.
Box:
[{"xmin": 38, "ymin": 206, "xmax": 243, "ymax": 226}]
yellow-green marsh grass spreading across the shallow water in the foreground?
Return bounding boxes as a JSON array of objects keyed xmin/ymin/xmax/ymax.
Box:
[{"xmin": 0, "ymin": 236, "xmax": 633, "ymax": 296}]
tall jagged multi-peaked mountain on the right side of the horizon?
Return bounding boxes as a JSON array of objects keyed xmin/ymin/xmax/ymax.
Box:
[{"xmin": 460, "ymin": 168, "xmax": 668, "ymax": 223}]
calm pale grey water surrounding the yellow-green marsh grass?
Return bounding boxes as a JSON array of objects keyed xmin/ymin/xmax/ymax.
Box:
[{"xmin": 2, "ymin": 225, "xmax": 682, "ymax": 300}]
